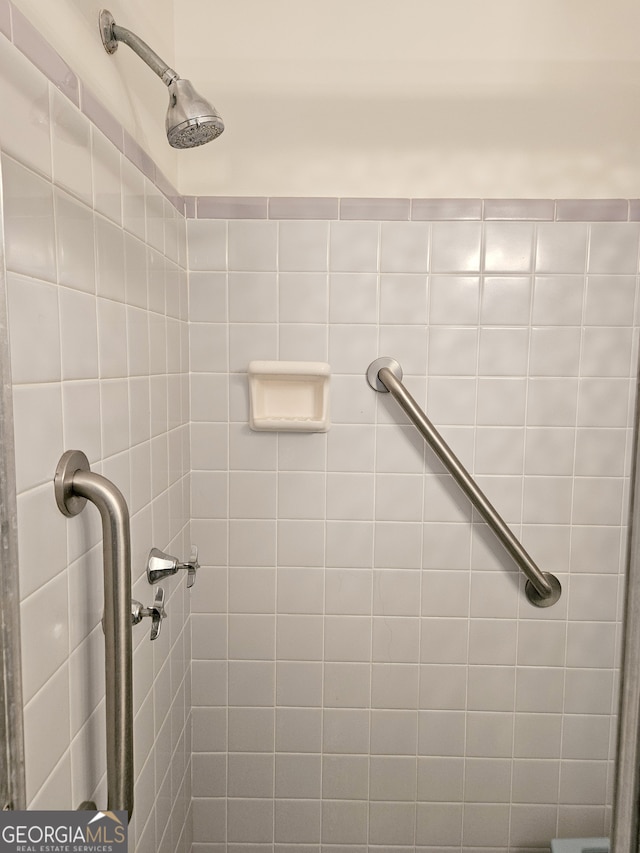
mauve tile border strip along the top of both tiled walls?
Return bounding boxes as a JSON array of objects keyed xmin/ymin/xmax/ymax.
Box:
[{"xmin": 0, "ymin": 0, "xmax": 640, "ymax": 222}]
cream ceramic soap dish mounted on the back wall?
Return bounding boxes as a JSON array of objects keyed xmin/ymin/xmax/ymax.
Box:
[{"xmin": 248, "ymin": 361, "xmax": 331, "ymax": 432}]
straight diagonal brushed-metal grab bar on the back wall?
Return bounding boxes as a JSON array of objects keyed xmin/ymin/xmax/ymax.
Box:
[{"xmin": 367, "ymin": 358, "xmax": 562, "ymax": 607}]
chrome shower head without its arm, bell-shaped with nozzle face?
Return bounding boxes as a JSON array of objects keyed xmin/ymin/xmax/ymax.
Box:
[{"xmin": 166, "ymin": 78, "xmax": 224, "ymax": 148}]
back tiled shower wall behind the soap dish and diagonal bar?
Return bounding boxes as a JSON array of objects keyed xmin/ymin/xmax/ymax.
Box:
[{"xmin": 188, "ymin": 205, "xmax": 640, "ymax": 853}]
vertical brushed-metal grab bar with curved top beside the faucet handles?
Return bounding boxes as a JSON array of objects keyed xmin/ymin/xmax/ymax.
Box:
[{"xmin": 54, "ymin": 450, "xmax": 134, "ymax": 819}]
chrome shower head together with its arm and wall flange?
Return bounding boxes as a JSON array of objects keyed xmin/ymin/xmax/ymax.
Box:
[{"xmin": 99, "ymin": 9, "xmax": 224, "ymax": 148}]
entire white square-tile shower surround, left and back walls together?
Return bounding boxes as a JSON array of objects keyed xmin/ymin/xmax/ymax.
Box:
[{"xmin": 0, "ymin": 5, "xmax": 640, "ymax": 853}]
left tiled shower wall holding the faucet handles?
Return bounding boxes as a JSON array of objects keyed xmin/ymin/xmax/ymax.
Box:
[{"xmin": 0, "ymin": 18, "xmax": 191, "ymax": 853}]
